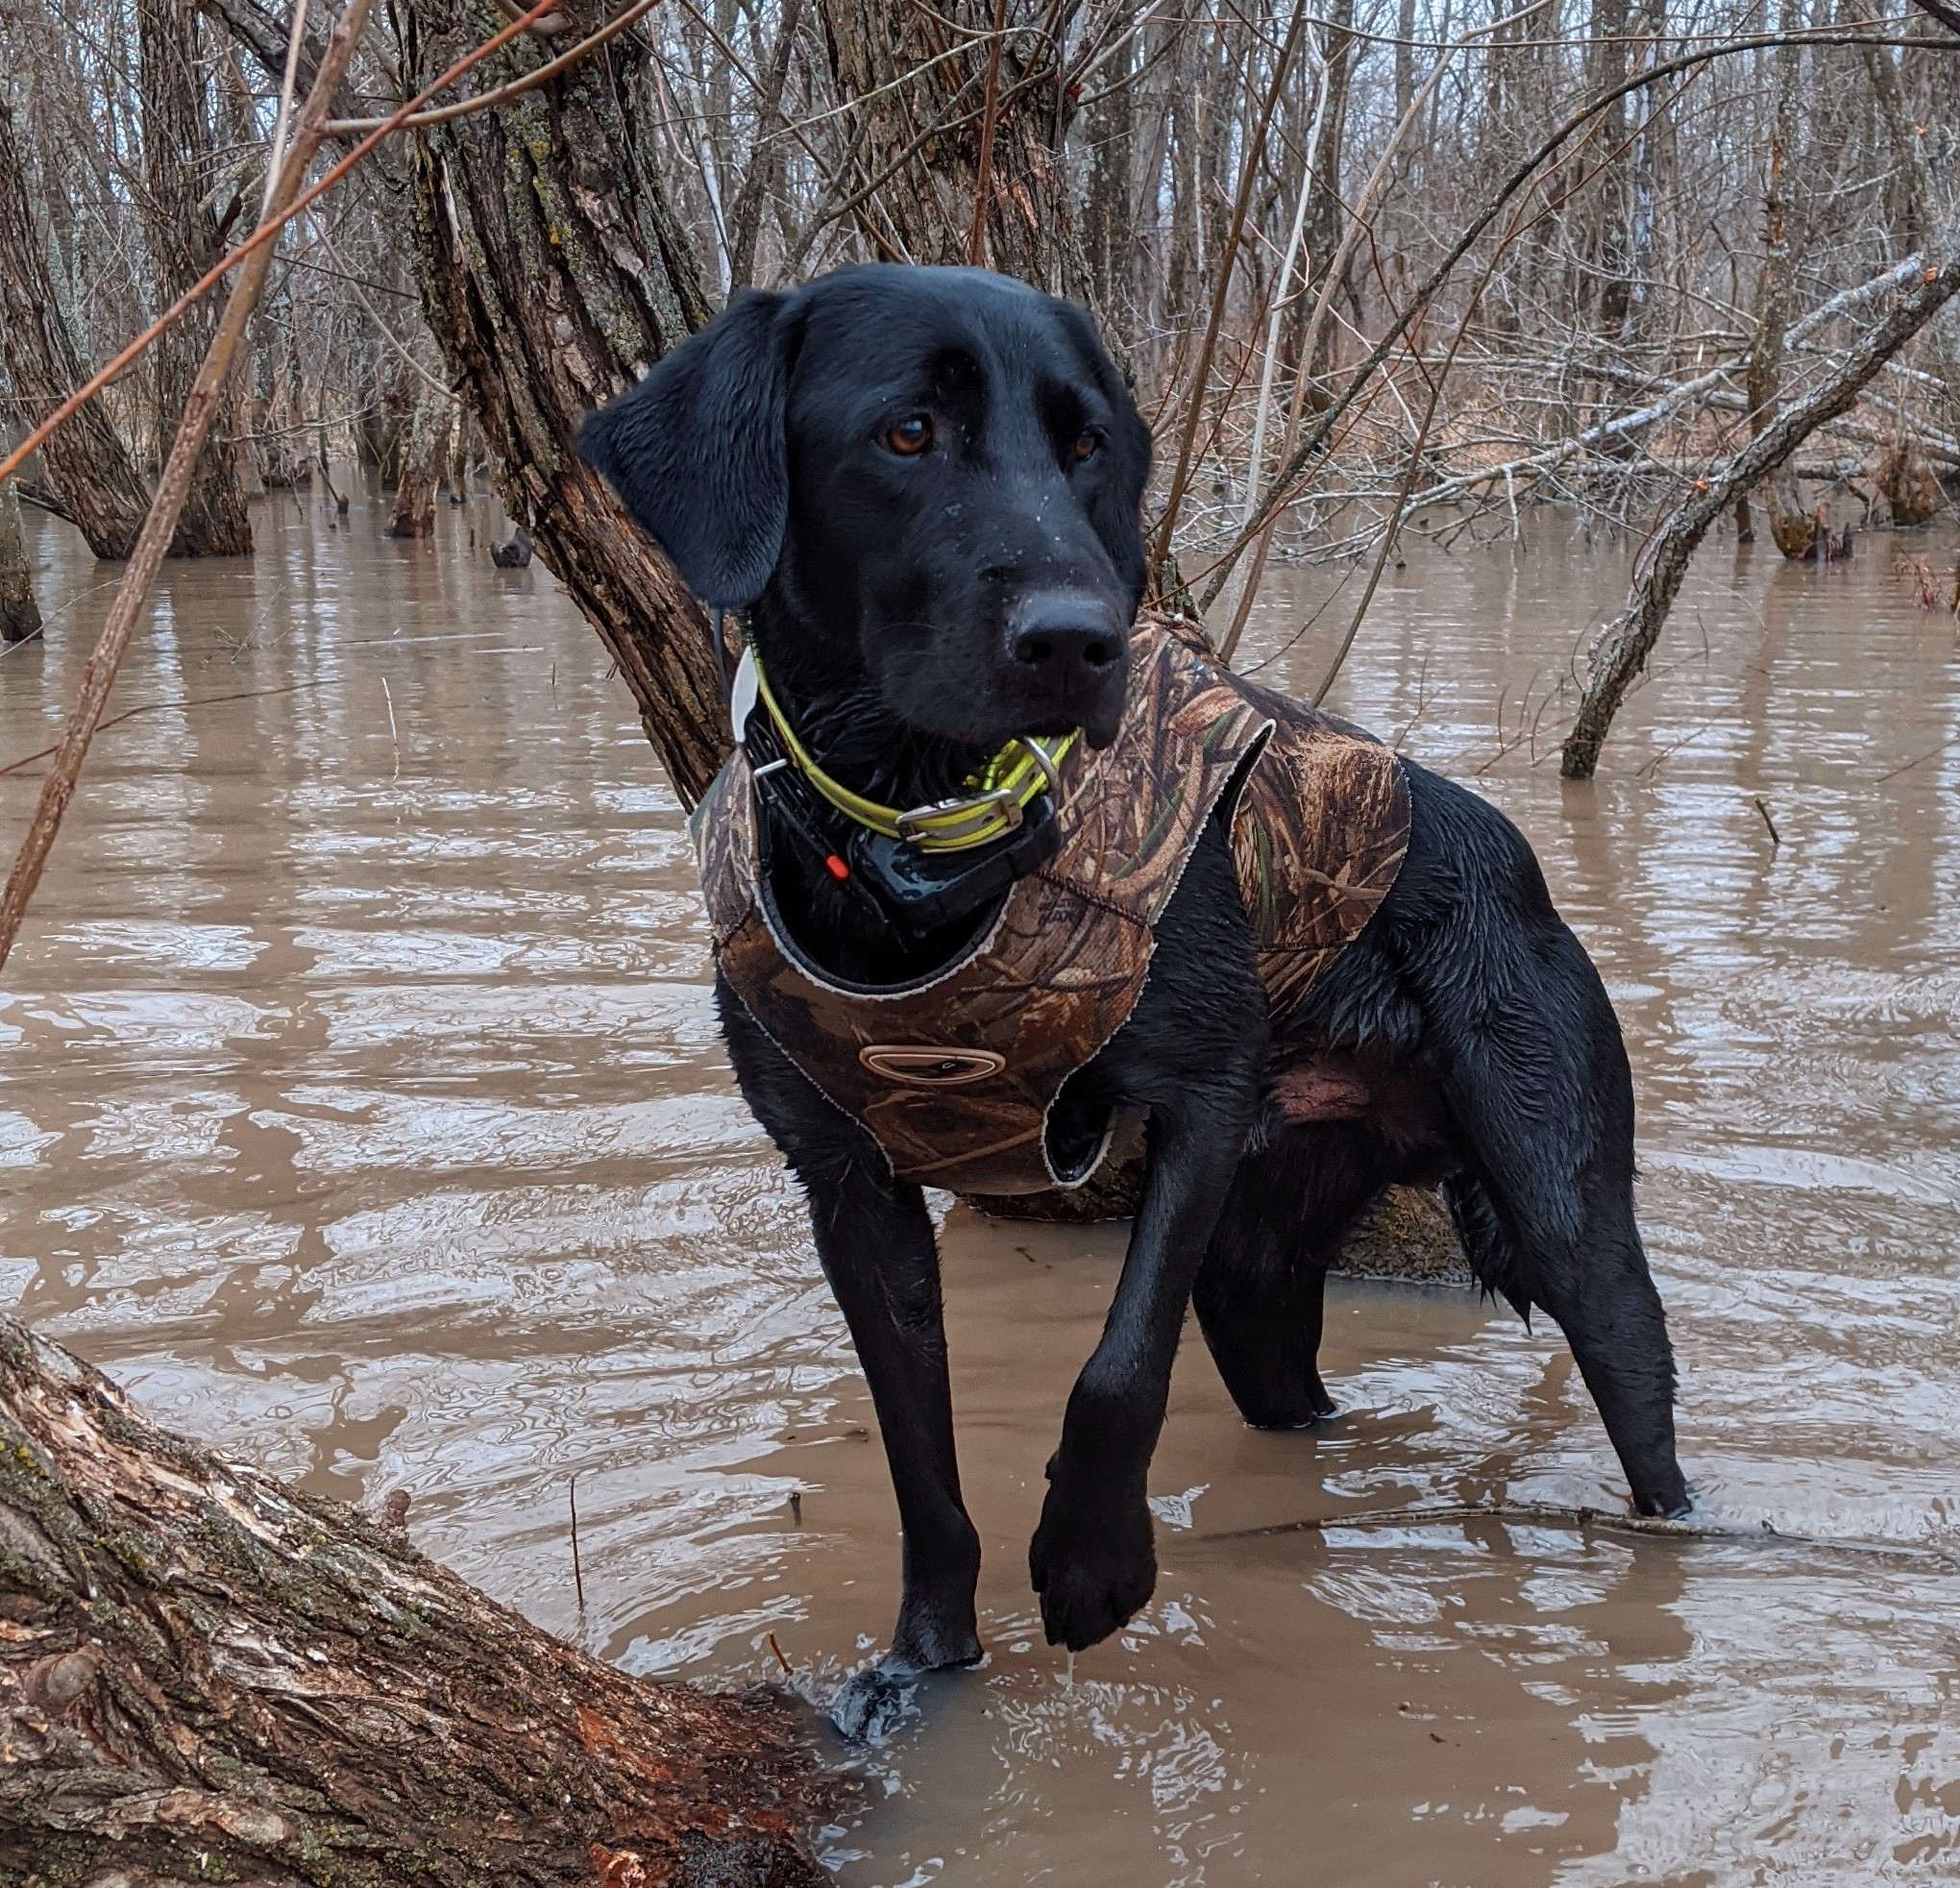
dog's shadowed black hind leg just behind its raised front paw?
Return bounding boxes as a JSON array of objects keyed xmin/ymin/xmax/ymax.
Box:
[{"xmin": 1191, "ymin": 1129, "xmax": 1380, "ymax": 1430}]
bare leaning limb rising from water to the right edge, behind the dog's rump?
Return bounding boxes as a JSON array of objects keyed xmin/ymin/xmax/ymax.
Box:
[{"xmin": 1558, "ymin": 257, "xmax": 1960, "ymax": 780}]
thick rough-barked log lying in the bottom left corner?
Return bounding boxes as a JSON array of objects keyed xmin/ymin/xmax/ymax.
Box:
[{"xmin": 0, "ymin": 1317, "xmax": 837, "ymax": 1888}]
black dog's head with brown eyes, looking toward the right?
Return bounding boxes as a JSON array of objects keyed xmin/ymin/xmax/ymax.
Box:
[{"xmin": 580, "ymin": 267, "xmax": 1150, "ymax": 748}]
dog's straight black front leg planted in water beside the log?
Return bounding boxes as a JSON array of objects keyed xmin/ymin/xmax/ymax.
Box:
[{"xmin": 716, "ymin": 986, "xmax": 980, "ymax": 1737}]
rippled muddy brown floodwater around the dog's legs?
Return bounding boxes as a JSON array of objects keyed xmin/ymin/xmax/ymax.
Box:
[{"xmin": 0, "ymin": 498, "xmax": 1960, "ymax": 1888}]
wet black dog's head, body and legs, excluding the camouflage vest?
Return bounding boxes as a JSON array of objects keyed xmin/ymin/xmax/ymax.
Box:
[{"xmin": 582, "ymin": 269, "xmax": 1687, "ymax": 1715}]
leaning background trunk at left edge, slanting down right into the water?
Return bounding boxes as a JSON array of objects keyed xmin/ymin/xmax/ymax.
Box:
[{"xmin": 0, "ymin": 98, "xmax": 149, "ymax": 559}]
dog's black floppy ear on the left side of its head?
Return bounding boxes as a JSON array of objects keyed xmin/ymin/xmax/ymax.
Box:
[{"xmin": 578, "ymin": 292, "xmax": 801, "ymax": 610}]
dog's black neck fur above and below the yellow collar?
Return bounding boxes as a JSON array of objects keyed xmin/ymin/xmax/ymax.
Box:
[{"xmin": 745, "ymin": 588, "xmax": 990, "ymax": 984}]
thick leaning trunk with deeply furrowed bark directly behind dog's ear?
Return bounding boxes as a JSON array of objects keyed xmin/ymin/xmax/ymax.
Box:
[{"xmin": 400, "ymin": 0, "xmax": 727, "ymax": 804}]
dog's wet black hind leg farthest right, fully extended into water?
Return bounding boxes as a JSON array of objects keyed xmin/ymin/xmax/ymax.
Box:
[{"xmin": 1449, "ymin": 944, "xmax": 1687, "ymax": 1515}]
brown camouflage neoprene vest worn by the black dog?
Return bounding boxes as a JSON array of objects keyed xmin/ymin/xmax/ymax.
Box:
[{"xmin": 694, "ymin": 616, "xmax": 1409, "ymax": 1194}]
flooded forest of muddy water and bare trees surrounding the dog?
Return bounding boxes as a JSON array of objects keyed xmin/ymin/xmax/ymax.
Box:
[{"xmin": 0, "ymin": 0, "xmax": 1960, "ymax": 1888}]
